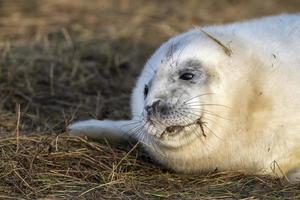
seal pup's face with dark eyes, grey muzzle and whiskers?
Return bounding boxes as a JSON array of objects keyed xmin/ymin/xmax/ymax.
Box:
[{"xmin": 143, "ymin": 39, "xmax": 210, "ymax": 147}]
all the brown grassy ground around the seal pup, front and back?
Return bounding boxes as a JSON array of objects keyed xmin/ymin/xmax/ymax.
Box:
[{"xmin": 0, "ymin": 0, "xmax": 300, "ymax": 199}]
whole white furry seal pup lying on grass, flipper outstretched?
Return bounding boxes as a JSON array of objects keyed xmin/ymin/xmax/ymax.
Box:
[{"xmin": 68, "ymin": 14, "xmax": 300, "ymax": 182}]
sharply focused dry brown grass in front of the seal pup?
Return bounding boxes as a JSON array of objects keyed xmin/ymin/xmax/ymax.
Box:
[{"xmin": 0, "ymin": 135, "xmax": 300, "ymax": 199}]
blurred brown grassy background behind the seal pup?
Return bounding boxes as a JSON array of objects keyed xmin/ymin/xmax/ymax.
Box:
[{"xmin": 0, "ymin": 0, "xmax": 300, "ymax": 133}]
